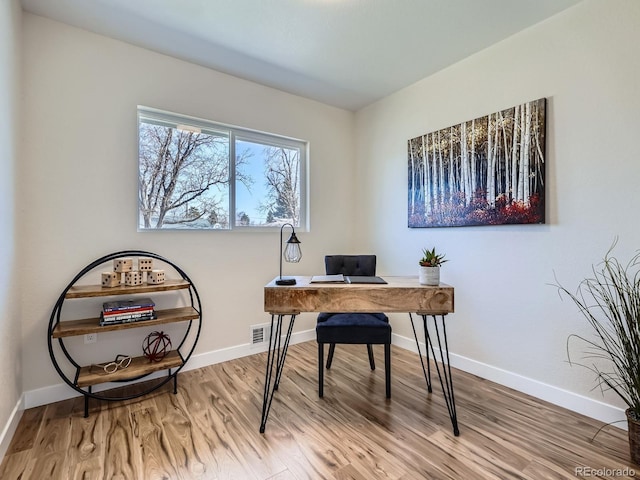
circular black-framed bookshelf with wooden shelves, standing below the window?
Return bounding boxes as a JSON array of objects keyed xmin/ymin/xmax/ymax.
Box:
[{"xmin": 47, "ymin": 250, "xmax": 202, "ymax": 418}]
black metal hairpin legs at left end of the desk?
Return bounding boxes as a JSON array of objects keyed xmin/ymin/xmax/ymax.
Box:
[{"xmin": 260, "ymin": 314, "xmax": 296, "ymax": 433}]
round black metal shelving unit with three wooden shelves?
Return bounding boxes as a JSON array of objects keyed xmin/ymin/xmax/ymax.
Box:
[{"xmin": 47, "ymin": 250, "xmax": 202, "ymax": 417}]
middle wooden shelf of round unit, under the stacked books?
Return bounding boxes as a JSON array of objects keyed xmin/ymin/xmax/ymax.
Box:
[{"xmin": 51, "ymin": 307, "xmax": 200, "ymax": 338}]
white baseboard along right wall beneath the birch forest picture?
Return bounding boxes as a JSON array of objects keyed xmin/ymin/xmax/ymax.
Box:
[{"xmin": 392, "ymin": 334, "xmax": 627, "ymax": 430}]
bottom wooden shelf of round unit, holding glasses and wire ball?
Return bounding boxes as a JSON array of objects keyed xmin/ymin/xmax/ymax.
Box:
[{"xmin": 76, "ymin": 350, "xmax": 183, "ymax": 388}]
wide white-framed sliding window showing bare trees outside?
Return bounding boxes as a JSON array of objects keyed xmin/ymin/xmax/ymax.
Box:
[{"xmin": 138, "ymin": 107, "xmax": 307, "ymax": 230}]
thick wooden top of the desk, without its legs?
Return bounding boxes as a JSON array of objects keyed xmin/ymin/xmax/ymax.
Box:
[{"xmin": 264, "ymin": 276, "xmax": 454, "ymax": 315}]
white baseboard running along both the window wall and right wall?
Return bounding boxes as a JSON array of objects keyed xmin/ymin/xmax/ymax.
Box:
[{"xmin": 21, "ymin": 329, "xmax": 626, "ymax": 428}]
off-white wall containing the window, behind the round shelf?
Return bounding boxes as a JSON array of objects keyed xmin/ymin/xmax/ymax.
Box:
[{"xmin": 18, "ymin": 13, "xmax": 354, "ymax": 403}]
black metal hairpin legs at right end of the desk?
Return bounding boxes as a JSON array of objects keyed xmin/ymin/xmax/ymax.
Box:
[{"xmin": 409, "ymin": 313, "xmax": 460, "ymax": 437}]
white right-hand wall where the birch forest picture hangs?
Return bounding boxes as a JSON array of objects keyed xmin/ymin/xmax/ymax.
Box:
[{"xmin": 356, "ymin": 0, "xmax": 640, "ymax": 416}]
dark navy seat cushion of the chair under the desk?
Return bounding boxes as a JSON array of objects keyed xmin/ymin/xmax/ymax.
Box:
[{"xmin": 316, "ymin": 312, "xmax": 391, "ymax": 344}]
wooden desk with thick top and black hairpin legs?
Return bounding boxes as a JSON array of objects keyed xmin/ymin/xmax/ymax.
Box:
[{"xmin": 260, "ymin": 276, "xmax": 459, "ymax": 436}]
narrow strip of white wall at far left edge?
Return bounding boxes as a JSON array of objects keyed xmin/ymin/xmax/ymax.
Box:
[{"xmin": 0, "ymin": 0, "xmax": 22, "ymax": 458}]
